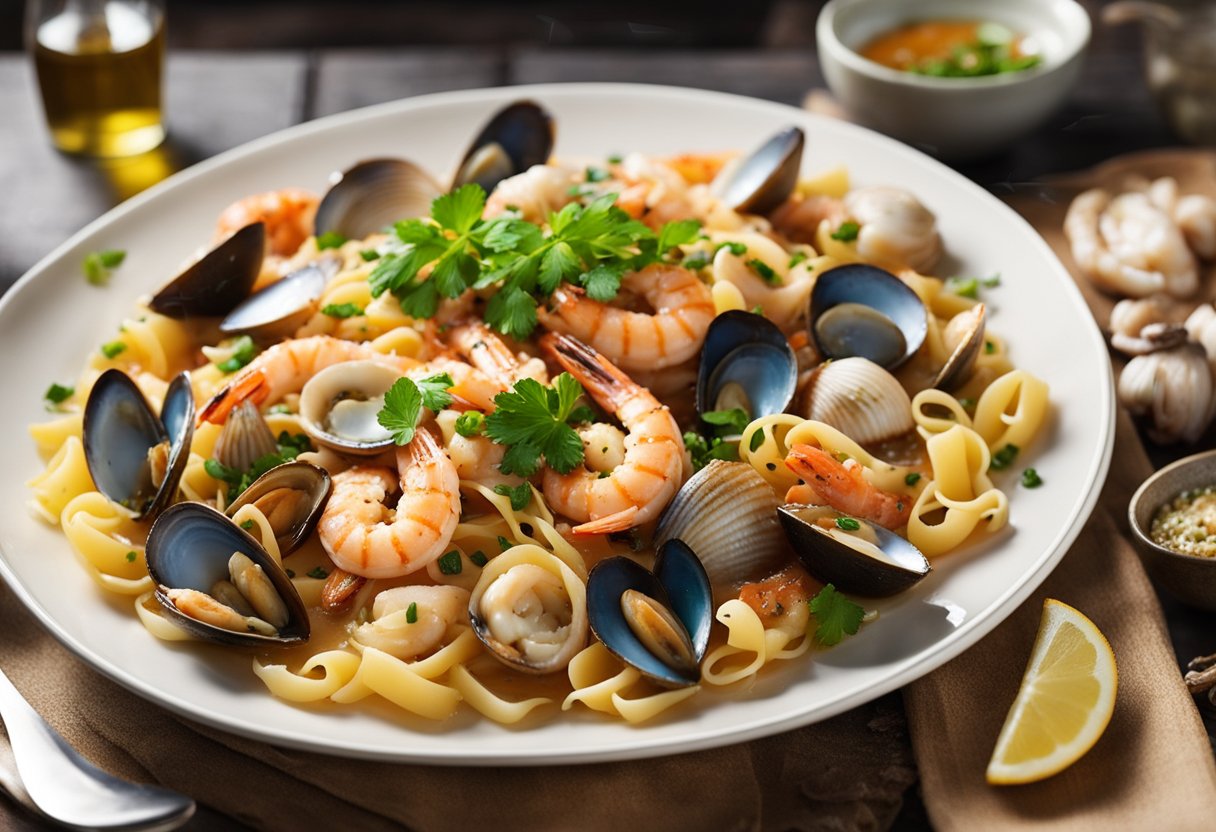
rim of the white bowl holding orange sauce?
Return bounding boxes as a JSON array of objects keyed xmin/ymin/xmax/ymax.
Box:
[{"xmin": 815, "ymin": 0, "xmax": 1093, "ymax": 90}]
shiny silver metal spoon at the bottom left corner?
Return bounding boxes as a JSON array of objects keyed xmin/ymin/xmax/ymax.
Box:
[{"xmin": 0, "ymin": 671, "xmax": 195, "ymax": 832}]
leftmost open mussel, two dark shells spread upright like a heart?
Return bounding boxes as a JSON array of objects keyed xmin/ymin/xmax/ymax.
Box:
[{"xmin": 84, "ymin": 369, "xmax": 195, "ymax": 518}]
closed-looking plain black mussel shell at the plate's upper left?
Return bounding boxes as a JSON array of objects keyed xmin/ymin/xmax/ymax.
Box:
[{"xmin": 148, "ymin": 223, "xmax": 266, "ymax": 317}]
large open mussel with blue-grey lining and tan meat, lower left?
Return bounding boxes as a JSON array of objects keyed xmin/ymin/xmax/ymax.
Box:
[{"xmin": 145, "ymin": 502, "xmax": 309, "ymax": 646}]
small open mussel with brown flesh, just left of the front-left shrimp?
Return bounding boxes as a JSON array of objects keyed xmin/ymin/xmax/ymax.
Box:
[{"xmin": 225, "ymin": 457, "xmax": 333, "ymax": 557}]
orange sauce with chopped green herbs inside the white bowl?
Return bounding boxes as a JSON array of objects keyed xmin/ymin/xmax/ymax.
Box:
[{"xmin": 858, "ymin": 21, "xmax": 1040, "ymax": 78}]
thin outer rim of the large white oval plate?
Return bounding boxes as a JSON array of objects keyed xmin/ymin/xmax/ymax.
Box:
[{"xmin": 0, "ymin": 81, "xmax": 1116, "ymax": 766}]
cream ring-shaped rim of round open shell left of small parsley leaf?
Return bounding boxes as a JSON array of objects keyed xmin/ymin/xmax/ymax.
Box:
[{"xmin": 299, "ymin": 360, "xmax": 401, "ymax": 456}]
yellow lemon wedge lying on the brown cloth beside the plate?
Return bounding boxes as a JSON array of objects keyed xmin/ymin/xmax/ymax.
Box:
[{"xmin": 987, "ymin": 598, "xmax": 1119, "ymax": 785}]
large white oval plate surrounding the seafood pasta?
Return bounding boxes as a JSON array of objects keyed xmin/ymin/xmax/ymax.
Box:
[{"xmin": 0, "ymin": 84, "xmax": 1114, "ymax": 765}]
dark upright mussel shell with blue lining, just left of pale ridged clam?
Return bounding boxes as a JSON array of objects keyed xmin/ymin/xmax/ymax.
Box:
[{"xmin": 697, "ymin": 310, "xmax": 798, "ymax": 418}]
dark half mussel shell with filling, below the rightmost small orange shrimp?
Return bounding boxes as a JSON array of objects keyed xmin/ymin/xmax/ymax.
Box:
[{"xmin": 777, "ymin": 505, "xmax": 931, "ymax": 597}]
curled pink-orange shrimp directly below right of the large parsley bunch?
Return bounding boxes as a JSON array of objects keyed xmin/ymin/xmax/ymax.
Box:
[{"xmin": 536, "ymin": 263, "xmax": 714, "ymax": 370}]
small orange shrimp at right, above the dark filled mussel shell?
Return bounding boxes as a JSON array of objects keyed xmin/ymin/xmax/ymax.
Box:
[{"xmin": 786, "ymin": 445, "xmax": 912, "ymax": 529}]
